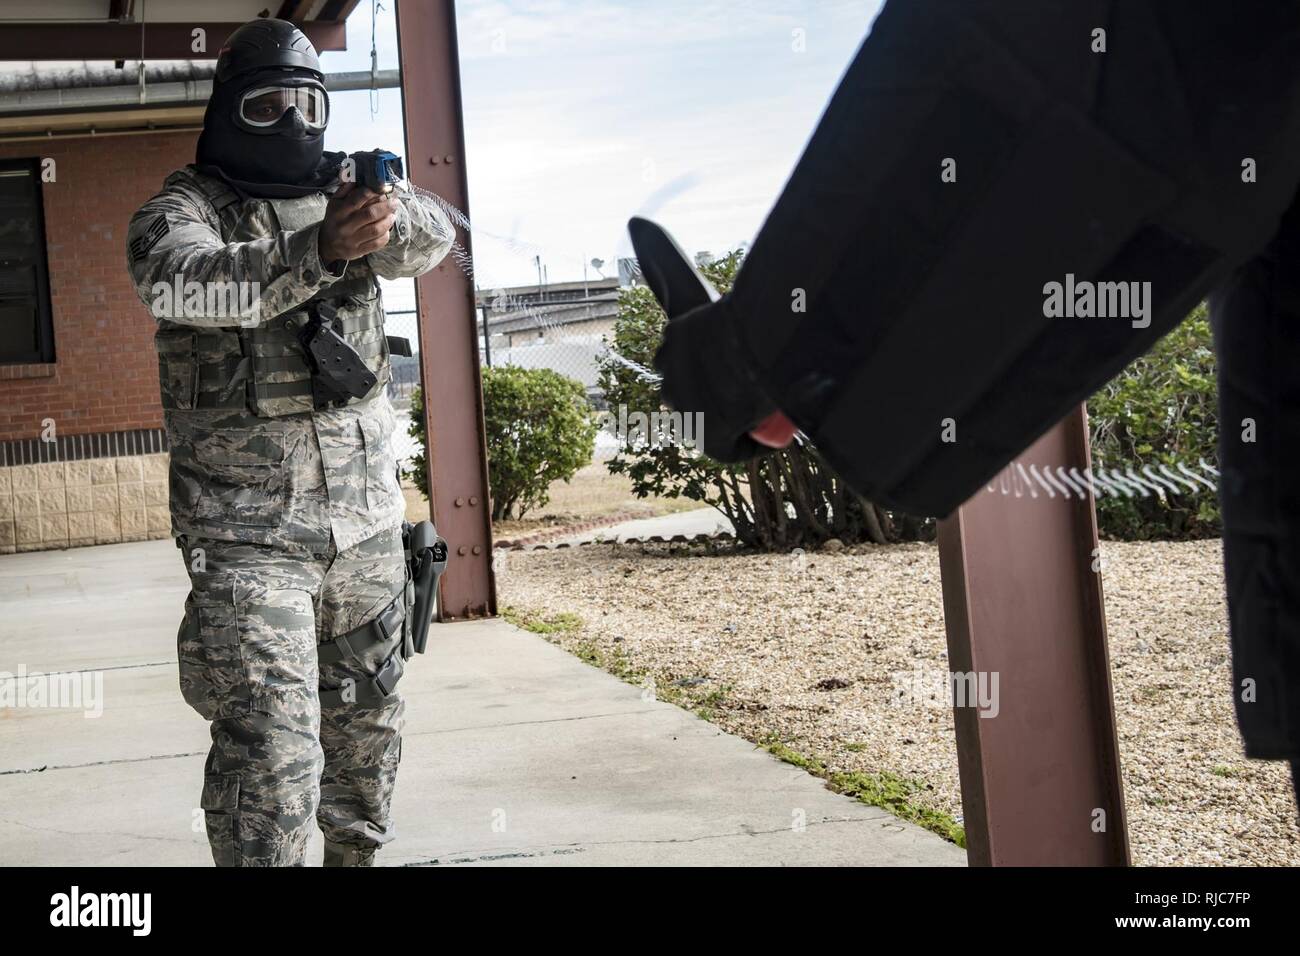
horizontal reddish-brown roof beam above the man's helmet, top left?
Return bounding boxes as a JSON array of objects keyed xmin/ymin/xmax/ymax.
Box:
[{"xmin": 0, "ymin": 21, "xmax": 347, "ymax": 60}]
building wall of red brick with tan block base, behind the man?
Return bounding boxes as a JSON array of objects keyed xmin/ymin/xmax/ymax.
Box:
[{"xmin": 0, "ymin": 133, "xmax": 196, "ymax": 554}]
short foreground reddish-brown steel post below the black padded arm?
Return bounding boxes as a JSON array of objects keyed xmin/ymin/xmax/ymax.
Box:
[{"xmin": 939, "ymin": 408, "xmax": 1128, "ymax": 866}]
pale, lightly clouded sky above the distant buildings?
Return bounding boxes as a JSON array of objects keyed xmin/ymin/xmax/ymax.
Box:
[{"xmin": 322, "ymin": 0, "xmax": 880, "ymax": 299}]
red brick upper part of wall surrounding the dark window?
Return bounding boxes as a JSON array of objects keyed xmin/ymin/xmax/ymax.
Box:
[{"xmin": 0, "ymin": 133, "xmax": 198, "ymax": 441}]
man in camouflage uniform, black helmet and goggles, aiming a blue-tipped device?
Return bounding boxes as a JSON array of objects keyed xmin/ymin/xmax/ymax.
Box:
[{"xmin": 127, "ymin": 20, "xmax": 454, "ymax": 866}]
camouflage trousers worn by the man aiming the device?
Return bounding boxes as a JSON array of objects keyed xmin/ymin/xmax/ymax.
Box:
[{"xmin": 178, "ymin": 528, "xmax": 406, "ymax": 866}]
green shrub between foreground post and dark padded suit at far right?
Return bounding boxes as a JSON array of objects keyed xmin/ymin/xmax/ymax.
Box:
[{"xmin": 1088, "ymin": 304, "xmax": 1222, "ymax": 541}]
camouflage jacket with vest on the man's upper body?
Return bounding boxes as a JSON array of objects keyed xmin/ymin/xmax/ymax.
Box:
[{"xmin": 127, "ymin": 166, "xmax": 455, "ymax": 551}]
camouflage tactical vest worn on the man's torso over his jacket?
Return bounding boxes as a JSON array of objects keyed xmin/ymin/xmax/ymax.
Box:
[{"xmin": 153, "ymin": 170, "xmax": 391, "ymax": 418}]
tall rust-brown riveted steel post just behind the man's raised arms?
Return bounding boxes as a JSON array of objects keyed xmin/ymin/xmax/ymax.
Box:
[{"xmin": 397, "ymin": 0, "xmax": 497, "ymax": 620}]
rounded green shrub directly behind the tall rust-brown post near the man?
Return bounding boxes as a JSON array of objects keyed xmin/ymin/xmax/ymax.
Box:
[{"xmin": 408, "ymin": 365, "xmax": 595, "ymax": 522}]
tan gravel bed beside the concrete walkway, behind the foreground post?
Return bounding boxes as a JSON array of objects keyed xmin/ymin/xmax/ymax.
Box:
[{"xmin": 497, "ymin": 541, "xmax": 1300, "ymax": 865}]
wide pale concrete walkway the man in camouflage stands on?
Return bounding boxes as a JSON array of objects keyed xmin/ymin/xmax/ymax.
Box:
[{"xmin": 0, "ymin": 541, "xmax": 965, "ymax": 865}]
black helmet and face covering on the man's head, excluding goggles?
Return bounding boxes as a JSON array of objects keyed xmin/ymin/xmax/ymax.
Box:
[{"xmin": 195, "ymin": 18, "xmax": 343, "ymax": 198}]
